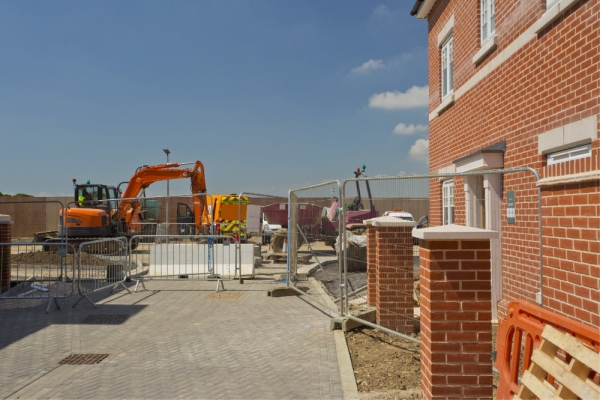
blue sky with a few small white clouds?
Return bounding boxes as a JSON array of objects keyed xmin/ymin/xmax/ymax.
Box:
[{"xmin": 0, "ymin": 0, "xmax": 428, "ymax": 196}]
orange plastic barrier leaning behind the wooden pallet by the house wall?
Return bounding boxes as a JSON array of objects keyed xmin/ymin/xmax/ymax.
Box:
[{"xmin": 495, "ymin": 300, "xmax": 600, "ymax": 400}]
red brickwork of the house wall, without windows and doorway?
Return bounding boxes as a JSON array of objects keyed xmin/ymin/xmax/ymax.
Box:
[{"xmin": 427, "ymin": 0, "xmax": 600, "ymax": 327}]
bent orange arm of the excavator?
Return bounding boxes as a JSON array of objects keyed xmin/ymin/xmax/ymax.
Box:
[{"xmin": 116, "ymin": 161, "xmax": 206, "ymax": 230}]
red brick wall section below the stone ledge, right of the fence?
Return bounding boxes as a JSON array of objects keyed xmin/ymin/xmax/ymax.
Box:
[{"xmin": 542, "ymin": 183, "xmax": 600, "ymax": 327}]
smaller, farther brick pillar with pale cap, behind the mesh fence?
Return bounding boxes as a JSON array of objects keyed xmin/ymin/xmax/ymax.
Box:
[{"xmin": 365, "ymin": 217, "xmax": 415, "ymax": 334}]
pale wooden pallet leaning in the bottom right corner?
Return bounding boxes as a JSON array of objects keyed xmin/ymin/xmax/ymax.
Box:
[{"xmin": 513, "ymin": 325, "xmax": 600, "ymax": 400}]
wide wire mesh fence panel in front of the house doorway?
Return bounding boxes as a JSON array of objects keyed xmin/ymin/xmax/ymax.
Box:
[{"xmin": 340, "ymin": 167, "xmax": 543, "ymax": 340}]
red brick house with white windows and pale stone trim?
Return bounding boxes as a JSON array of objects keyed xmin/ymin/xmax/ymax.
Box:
[{"xmin": 411, "ymin": 0, "xmax": 600, "ymax": 327}]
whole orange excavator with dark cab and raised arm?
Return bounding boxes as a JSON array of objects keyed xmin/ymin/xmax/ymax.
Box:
[{"xmin": 34, "ymin": 161, "xmax": 211, "ymax": 246}]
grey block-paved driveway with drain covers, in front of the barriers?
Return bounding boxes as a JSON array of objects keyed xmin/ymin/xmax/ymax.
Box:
[{"xmin": 0, "ymin": 280, "xmax": 343, "ymax": 399}]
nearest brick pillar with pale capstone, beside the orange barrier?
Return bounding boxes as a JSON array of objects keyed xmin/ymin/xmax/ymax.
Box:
[{"xmin": 415, "ymin": 225, "xmax": 498, "ymax": 399}]
